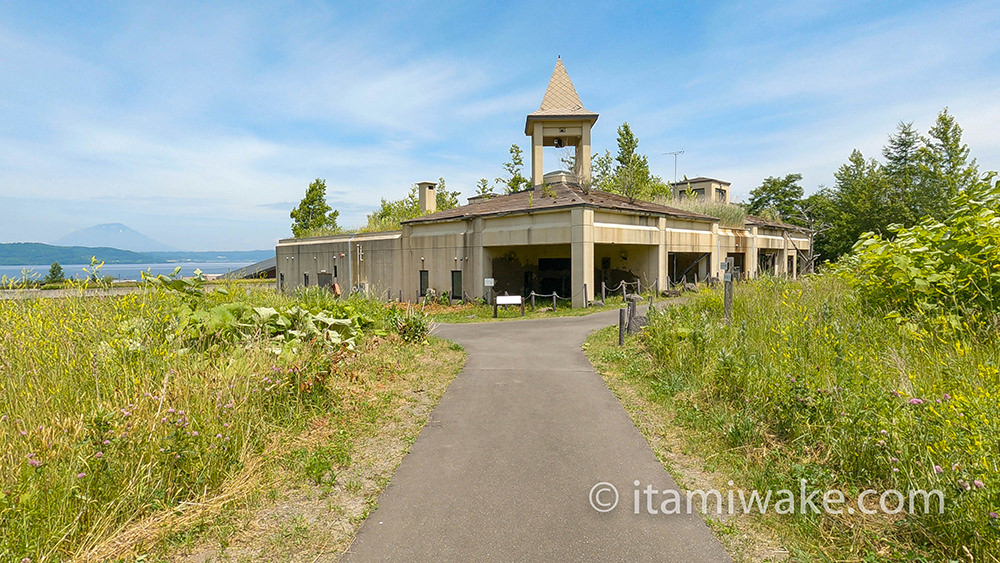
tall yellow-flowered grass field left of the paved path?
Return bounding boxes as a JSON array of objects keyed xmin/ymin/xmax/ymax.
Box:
[{"xmin": 0, "ymin": 284, "xmax": 462, "ymax": 562}]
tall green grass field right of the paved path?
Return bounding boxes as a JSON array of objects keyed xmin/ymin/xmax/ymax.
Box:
[{"xmin": 588, "ymin": 276, "xmax": 1000, "ymax": 561}]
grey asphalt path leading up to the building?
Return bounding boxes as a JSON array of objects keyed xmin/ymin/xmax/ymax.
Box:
[{"xmin": 344, "ymin": 311, "xmax": 731, "ymax": 562}]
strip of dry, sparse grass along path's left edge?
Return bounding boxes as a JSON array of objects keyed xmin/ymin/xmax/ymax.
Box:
[{"xmin": 157, "ymin": 337, "xmax": 464, "ymax": 563}]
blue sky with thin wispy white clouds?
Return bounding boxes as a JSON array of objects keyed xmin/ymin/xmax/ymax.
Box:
[{"xmin": 0, "ymin": 0, "xmax": 1000, "ymax": 250}]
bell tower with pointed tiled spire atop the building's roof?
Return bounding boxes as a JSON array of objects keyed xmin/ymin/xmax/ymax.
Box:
[{"xmin": 524, "ymin": 57, "xmax": 597, "ymax": 188}]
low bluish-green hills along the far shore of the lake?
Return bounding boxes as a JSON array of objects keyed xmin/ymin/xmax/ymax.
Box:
[{"xmin": 0, "ymin": 242, "xmax": 274, "ymax": 266}]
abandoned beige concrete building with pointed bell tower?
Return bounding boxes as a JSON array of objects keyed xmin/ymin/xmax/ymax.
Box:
[{"xmin": 275, "ymin": 60, "xmax": 810, "ymax": 307}]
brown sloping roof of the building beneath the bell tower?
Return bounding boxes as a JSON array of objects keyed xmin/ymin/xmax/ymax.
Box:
[{"xmin": 403, "ymin": 183, "xmax": 718, "ymax": 224}]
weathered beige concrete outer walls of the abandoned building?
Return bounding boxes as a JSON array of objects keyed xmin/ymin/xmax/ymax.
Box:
[{"xmin": 275, "ymin": 207, "xmax": 809, "ymax": 306}]
